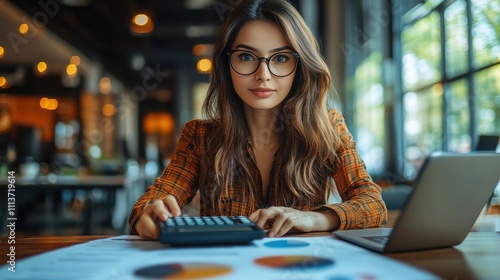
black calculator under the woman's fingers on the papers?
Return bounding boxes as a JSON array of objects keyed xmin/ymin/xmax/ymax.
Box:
[{"xmin": 159, "ymin": 216, "xmax": 265, "ymax": 246}]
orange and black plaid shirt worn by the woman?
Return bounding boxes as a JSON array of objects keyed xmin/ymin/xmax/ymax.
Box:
[{"xmin": 129, "ymin": 110, "xmax": 387, "ymax": 234}]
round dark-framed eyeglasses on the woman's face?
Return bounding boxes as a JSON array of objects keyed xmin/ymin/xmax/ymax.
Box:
[{"xmin": 227, "ymin": 50, "xmax": 300, "ymax": 77}]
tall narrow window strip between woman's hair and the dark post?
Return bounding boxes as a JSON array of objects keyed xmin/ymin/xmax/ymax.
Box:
[{"xmin": 343, "ymin": 0, "xmax": 393, "ymax": 178}]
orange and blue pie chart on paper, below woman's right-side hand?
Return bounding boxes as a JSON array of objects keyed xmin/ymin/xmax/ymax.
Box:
[{"xmin": 254, "ymin": 256, "xmax": 334, "ymax": 270}]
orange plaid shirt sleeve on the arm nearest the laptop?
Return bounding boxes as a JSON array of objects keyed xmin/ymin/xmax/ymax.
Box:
[{"xmin": 316, "ymin": 110, "xmax": 387, "ymax": 230}]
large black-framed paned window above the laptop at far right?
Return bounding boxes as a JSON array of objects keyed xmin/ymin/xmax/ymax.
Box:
[{"xmin": 393, "ymin": 0, "xmax": 500, "ymax": 177}]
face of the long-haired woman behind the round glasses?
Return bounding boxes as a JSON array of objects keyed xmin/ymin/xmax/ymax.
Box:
[{"xmin": 229, "ymin": 21, "xmax": 296, "ymax": 110}]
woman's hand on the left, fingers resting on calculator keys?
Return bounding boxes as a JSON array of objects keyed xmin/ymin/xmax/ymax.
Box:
[{"xmin": 135, "ymin": 194, "xmax": 181, "ymax": 239}]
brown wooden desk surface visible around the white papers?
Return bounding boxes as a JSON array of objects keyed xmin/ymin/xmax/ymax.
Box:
[{"xmin": 0, "ymin": 232, "xmax": 500, "ymax": 279}]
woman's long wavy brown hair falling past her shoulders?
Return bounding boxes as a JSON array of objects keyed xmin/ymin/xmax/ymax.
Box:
[{"xmin": 202, "ymin": 0, "xmax": 339, "ymax": 212}]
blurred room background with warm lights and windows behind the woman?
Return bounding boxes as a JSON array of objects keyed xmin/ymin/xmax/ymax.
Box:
[{"xmin": 0, "ymin": 0, "xmax": 500, "ymax": 235}]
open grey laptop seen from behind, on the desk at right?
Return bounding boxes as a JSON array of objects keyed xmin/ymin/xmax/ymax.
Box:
[{"xmin": 333, "ymin": 152, "xmax": 500, "ymax": 253}]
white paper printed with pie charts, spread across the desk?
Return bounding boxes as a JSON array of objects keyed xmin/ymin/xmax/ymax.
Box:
[{"xmin": 0, "ymin": 235, "xmax": 439, "ymax": 280}]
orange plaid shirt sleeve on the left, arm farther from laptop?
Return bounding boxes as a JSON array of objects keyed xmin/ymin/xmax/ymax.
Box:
[{"xmin": 129, "ymin": 120, "xmax": 206, "ymax": 234}]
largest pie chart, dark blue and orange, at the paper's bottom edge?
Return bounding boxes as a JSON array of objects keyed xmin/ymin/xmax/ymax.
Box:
[{"xmin": 134, "ymin": 262, "xmax": 232, "ymax": 279}]
